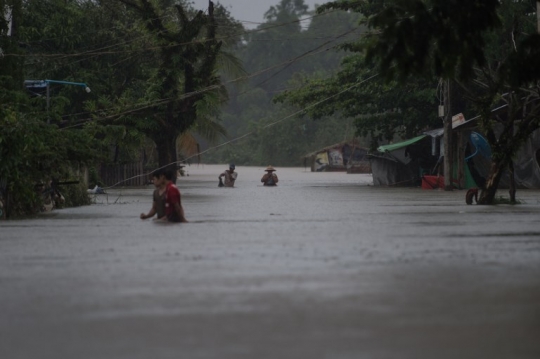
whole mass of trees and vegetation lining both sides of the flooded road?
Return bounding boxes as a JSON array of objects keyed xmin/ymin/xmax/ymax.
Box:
[{"xmin": 0, "ymin": 0, "xmax": 540, "ymax": 216}]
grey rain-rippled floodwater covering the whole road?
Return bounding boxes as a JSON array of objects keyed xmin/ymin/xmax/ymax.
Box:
[{"xmin": 0, "ymin": 165, "xmax": 540, "ymax": 359}]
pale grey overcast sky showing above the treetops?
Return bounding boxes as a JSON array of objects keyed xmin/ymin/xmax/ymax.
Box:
[{"xmin": 190, "ymin": 0, "xmax": 322, "ymax": 28}]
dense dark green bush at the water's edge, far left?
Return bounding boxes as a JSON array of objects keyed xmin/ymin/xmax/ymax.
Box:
[{"xmin": 0, "ymin": 110, "xmax": 95, "ymax": 216}]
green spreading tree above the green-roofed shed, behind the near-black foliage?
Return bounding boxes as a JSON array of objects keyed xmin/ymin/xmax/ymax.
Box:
[{"xmin": 275, "ymin": 2, "xmax": 440, "ymax": 148}]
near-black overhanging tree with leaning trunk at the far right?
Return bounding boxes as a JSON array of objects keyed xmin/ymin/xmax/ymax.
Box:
[{"xmin": 278, "ymin": 0, "xmax": 540, "ymax": 204}]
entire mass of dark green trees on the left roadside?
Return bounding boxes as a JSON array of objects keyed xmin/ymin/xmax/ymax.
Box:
[{"xmin": 0, "ymin": 0, "xmax": 241, "ymax": 217}]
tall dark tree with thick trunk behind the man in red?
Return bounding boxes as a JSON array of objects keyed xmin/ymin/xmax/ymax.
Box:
[{"xmin": 113, "ymin": 0, "xmax": 224, "ymax": 177}]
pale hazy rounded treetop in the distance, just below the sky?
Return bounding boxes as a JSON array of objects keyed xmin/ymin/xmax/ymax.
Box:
[{"xmin": 239, "ymin": 0, "xmax": 358, "ymax": 93}]
